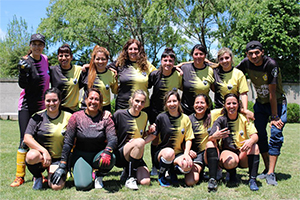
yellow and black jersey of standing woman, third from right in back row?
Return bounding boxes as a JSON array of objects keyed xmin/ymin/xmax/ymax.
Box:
[{"xmin": 181, "ymin": 63, "xmax": 214, "ymax": 115}]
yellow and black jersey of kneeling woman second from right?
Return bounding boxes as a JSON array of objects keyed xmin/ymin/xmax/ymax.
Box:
[{"xmin": 189, "ymin": 114, "xmax": 210, "ymax": 154}]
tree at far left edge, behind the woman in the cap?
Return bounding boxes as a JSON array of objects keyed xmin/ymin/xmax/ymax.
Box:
[{"xmin": 0, "ymin": 16, "xmax": 30, "ymax": 77}]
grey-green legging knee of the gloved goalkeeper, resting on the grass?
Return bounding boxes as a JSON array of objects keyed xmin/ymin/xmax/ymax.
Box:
[{"xmin": 73, "ymin": 157, "xmax": 93, "ymax": 191}]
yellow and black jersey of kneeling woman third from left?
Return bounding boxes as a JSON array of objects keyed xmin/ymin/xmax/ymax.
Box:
[{"xmin": 113, "ymin": 109, "xmax": 148, "ymax": 149}]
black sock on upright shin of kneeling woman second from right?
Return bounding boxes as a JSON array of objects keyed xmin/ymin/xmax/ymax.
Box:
[{"xmin": 206, "ymin": 148, "xmax": 219, "ymax": 179}]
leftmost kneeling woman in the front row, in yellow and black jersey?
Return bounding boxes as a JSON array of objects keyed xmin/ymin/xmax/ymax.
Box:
[{"xmin": 24, "ymin": 88, "xmax": 71, "ymax": 190}]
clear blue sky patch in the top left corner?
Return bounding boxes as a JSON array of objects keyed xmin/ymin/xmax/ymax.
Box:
[{"xmin": 0, "ymin": 0, "xmax": 49, "ymax": 38}]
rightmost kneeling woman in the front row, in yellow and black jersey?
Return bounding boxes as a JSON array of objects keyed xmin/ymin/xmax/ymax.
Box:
[{"xmin": 211, "ymin": 93, "xmax": 259, "ymax": 191}]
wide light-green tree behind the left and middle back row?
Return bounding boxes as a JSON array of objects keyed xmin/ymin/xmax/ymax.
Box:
[{"xmin": 39, "ymin": 0, "xmax": 186, "ymax": 64}]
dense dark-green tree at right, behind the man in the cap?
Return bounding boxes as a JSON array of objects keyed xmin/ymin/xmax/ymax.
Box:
[{"xmin": 216, "ymin": 0, "xmax": 300, "ymax": 82}]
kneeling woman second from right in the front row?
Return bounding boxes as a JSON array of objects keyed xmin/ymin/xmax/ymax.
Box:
[{"xmin": 187, "ymin": 94, "xmax": 219, "ymax": 192}]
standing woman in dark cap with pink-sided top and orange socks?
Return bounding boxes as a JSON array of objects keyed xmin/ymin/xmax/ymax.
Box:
[{"xmin": 10, "ymin": 33, "xmax": 50, "ymax": 187}]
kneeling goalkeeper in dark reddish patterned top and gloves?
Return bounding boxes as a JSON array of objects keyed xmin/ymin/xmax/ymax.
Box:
[{"xmin": 51, "ymin": 88, "xmax": 117, "ymax": 191}]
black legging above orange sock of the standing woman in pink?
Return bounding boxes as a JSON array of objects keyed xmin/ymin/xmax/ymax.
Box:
[{"xmin": 18, "ymin": 110, "xmax": 36, "ymax": 149}]
